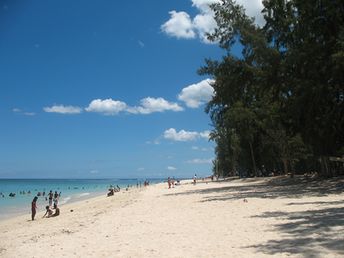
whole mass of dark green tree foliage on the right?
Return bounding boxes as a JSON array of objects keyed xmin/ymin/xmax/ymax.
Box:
[{"xmin": 203, "ymin": 0, "xmax": 344, "ymax": 175}]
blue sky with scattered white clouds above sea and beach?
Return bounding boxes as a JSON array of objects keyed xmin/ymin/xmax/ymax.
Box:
[{"xmin": 0, "ymin": 0, "xmax": 262, "ymax": 178}]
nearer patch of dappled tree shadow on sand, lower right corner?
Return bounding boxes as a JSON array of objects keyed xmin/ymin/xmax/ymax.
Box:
[{"xmin": 247, "ymin": 205, "xmax": 344, "ymax": 257}]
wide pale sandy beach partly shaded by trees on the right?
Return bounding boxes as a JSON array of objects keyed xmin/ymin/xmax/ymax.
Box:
[{"xmin": 0, "ymin": 177, "xmax": 344, "ymax": 257}]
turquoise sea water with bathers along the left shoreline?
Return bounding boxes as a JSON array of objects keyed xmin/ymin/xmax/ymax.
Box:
[{"xmin": 0, "ymin": 179, "xmax": 162, "ymax": 219}]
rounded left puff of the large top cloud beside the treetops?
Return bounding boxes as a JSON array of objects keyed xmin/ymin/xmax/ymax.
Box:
[{"xmin": 161, "ymin": 11, "xmax": 196, "ymax": 39}]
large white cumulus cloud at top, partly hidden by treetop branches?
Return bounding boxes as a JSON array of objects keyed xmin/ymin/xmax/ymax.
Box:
[{"xmin": 161, "ymin": 0, "xmax": 264, "ymax": 43}]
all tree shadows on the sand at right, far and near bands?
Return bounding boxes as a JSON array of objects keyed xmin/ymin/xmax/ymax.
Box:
[{"xmin": 165, "ymin": 177, "xmax": 344, "ymax": 257}]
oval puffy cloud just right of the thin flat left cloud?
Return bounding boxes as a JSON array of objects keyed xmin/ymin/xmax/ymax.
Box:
[{"xmin": 85, "ymin": 99, "xmax": 127, "ymax": 115}]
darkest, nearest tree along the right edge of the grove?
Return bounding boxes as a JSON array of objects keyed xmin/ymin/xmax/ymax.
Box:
[{"xmin": 264, "ymin": 0, "xmax": 344, "ymax": 175}]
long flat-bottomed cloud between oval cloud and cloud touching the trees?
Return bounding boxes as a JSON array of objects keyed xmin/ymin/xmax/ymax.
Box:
[{"xmin": 128, "ymin": 97, "xmax": 183, "ymax": 114}]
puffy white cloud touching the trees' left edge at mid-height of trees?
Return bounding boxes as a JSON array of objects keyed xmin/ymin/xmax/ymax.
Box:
[{"xmin": 178, "ymin": 79, "xmax": 214, "ymax": 108}]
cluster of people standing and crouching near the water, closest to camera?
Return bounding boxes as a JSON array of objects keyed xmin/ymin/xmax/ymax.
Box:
[{"xmin": 31, "ymin": 190, "xmax": 61, "ymax": 220}]
